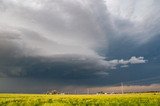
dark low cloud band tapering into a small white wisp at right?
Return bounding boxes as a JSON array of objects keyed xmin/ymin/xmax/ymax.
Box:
[{"xmin": 0, "ymin": 55, "xmax": 147, "ymax": 78}]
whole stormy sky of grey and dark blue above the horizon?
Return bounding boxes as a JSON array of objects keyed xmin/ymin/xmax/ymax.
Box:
[{"xmin": 0, "ymin": 0, "xmax": 160, "ymax": 92}]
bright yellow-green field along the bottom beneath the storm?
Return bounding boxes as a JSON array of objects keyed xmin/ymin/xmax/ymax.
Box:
[{"xmin": 0, "ymin": 93, "xmax": 160, "ymax": 106}]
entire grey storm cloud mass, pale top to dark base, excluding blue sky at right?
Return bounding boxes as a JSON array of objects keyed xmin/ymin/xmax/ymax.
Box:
[{"xmin": 0, "ymin": 0, "xmax": 160, "ymax": 88}]
